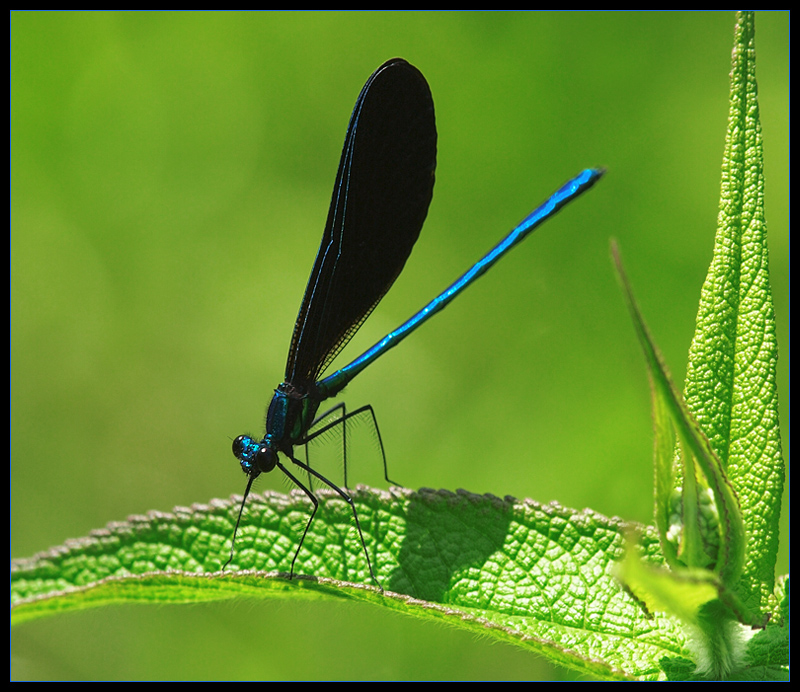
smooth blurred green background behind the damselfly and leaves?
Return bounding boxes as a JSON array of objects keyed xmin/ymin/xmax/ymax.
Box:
[{"xmin": 10, "ymin": 12, "xmax": 789, "ymax": 679}]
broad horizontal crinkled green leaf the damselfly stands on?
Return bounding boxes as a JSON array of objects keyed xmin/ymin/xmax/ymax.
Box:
[{"xmin": 11, "ymin": 488, "xmax": 686, "ymax": 678}]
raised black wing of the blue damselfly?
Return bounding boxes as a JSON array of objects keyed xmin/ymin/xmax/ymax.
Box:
[{"xmin": 285, "ymin": 58, "xmax": 436, "ymax": 387}]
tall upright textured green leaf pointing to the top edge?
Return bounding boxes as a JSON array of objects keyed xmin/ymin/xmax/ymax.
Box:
[{"xmin": 685, "ymin": 12, "xmax": 784, "ymax": 610}]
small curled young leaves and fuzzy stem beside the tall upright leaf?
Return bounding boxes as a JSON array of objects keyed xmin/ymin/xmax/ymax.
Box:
[{"xmin": 612, "ymin": 245, "xmax": 766, "ymax": 679}]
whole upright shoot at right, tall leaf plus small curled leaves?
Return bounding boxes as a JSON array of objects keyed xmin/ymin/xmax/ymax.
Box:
[{"xmin": 612, "ymin": 12, "xmax": 788, "ymax": 679}]
